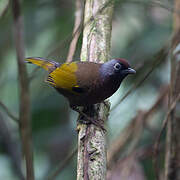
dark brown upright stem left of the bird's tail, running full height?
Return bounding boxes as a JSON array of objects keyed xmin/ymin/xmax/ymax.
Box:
[{"xmin": 11, "ymin": 0, "xmax": 34, "ymax": 180}]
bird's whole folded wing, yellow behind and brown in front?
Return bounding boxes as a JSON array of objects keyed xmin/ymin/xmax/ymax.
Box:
[{"xmin": 47, "ymin": 62, "xmax": 101, "ymax": 94}]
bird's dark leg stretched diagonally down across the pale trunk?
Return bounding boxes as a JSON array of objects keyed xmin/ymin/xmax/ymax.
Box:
[{"xmin": 71, "ymin": 106, "xmax": 106, "ymax": 131}]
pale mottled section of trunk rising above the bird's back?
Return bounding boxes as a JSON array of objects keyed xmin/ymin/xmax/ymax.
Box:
[{"xmin": 81, "ymin": 0, "xmax": 113, "ymax": 62}]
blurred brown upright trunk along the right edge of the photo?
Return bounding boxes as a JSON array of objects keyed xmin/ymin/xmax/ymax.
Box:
[{"xmin": 165, "ymin": 0, "xmax": 180, "ymax": 180}]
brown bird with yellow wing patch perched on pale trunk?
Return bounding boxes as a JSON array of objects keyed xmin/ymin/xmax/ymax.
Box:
[{"xmin": 26, "ymin": 57, "xmax": 136, "ymax": 128}]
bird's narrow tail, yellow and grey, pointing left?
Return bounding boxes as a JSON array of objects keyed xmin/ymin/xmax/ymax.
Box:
[{"xmin": 26, "ymin": 57, "xmax": 59, "ymax": 72}]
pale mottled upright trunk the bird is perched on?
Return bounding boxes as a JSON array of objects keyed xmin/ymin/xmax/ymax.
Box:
[{"xmin": 77, "ymin": 0, "xmax": 113, "ymax": 180}]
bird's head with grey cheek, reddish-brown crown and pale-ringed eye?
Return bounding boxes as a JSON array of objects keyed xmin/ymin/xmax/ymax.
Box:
[{"xmin": 100, "ymin": 59, "xmax": 136, "ymax": 80}]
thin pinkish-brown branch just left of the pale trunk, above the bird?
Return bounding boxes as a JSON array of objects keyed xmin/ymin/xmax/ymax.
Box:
[{"xmin": 66, "ymin": 0, "xmax": 84, "ymax": 62}]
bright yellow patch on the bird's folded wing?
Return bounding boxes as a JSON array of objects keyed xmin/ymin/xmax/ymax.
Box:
[{"xmin": 47, "ymin": 62, "xmax": 78, "ymax": 91}]
